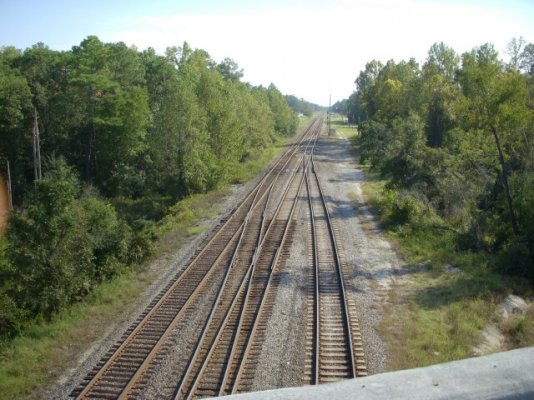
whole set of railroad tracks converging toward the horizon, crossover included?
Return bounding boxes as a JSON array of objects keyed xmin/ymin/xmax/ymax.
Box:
[{"xmin": 71, "ymin": 114, "xmax": 365, "ymax": 399}]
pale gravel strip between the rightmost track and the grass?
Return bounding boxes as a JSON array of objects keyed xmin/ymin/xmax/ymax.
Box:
[{"xmin": 316, "ymin": 134, "xmax": 403, "ymax": 374}]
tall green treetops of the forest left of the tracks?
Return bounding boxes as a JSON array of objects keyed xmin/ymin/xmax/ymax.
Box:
[{"xmin": 0, "ymin": 36, "xmax": 297, "ymax": 204}]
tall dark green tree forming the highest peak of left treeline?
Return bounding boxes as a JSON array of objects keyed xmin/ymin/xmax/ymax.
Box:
[{"xmin": 65, "ymin": 36, "xmax": 149, "ymax": 194}]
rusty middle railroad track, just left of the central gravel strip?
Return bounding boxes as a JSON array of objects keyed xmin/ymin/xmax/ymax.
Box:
[{"xmin": 174, "ymin": 120, "xmax": 322, "ymax": 399}]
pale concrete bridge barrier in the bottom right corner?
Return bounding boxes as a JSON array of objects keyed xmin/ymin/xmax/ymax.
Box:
[{"xmin": 216, "ymin": 347, "xmax": 534, "ymax": 400}]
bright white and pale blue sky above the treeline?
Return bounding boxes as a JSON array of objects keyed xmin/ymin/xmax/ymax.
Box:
[{"xmin": 0, "ymin": 0, "xmax": 534, "ymax": 105}]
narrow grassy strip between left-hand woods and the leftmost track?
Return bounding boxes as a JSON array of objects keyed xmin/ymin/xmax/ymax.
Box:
[{"xmin": 0, "ymin": 117, "xmax": 311, "ymax": 399}]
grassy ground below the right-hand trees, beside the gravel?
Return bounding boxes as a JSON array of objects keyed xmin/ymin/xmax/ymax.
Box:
[{"xmin": 362, "ymin": 166, "xmax": 534, "ymax": 370}]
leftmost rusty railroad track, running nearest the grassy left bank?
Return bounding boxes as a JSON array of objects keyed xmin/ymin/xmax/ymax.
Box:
[{"xmin": 71, "ymin": 119, "xmax": 322, "ymax": 399}]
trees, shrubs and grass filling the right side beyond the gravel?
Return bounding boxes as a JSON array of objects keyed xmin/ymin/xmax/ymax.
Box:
[{"xmin": 337, "ymin": 36, "xmax": 534, "ymax": 369}]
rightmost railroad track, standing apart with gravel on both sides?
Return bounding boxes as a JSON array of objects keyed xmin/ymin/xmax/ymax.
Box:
[{"xmin": 306, "ymin": 148, "xmax": 367, "ymax": 384}]
